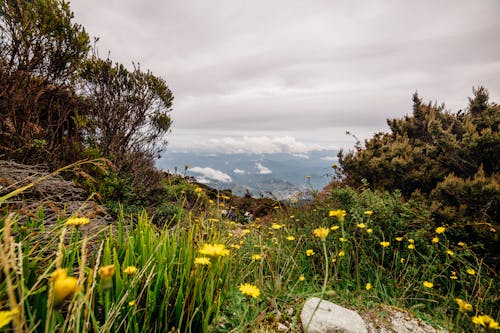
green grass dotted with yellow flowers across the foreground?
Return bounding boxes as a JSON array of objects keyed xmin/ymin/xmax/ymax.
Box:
[{"xmin": 0, "ymin": 170, "xmax": 499, "ymax": 332}]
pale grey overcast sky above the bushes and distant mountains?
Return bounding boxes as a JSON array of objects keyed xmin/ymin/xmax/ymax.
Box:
[{"xmin": 71, "ymin": 0, "xmax": 500, "ymax": 151}]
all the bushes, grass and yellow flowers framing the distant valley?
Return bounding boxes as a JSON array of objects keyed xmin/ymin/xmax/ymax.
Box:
[{"xmin": 0, "ymin": 0, "xmax": 500, "ymax": 332}]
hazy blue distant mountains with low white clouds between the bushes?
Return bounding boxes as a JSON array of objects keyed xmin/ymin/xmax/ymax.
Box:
[{"xmin": 157, "ymin": 150, "xmax": 338, "ymax": 199}]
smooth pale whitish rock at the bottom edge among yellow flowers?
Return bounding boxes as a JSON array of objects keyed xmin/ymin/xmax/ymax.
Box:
[{"xmin": 300, "ymin": 297, "xmax": 368, "ymax": 333}]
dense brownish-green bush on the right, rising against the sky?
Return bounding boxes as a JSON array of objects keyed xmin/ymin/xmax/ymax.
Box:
[{"xmin": 339, "ymin": 87, "xmax": 500, "ymax": 264}]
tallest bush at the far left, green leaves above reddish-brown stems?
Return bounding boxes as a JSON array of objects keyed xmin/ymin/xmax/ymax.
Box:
[{"xmin": 0, "ymin": 0, "xmax": 89, "ymax": 167}]
